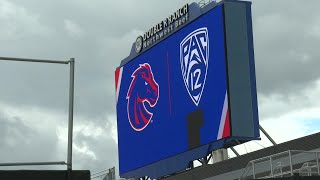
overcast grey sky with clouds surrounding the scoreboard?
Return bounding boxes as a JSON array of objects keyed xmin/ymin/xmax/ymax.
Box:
[{"xmin": 0, "ymin": 0, "xmax": 320, "ymax": 179}]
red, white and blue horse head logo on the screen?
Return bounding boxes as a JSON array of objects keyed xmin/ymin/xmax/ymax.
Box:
[{"xmin": 127, "ymin": 63, "xmax": 159, "ymax": 131}]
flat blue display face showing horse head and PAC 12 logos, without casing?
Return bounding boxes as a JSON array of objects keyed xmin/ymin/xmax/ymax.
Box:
[{"xmin": 116, "ymin": 6, "xmax": 231, "ymax": 175}]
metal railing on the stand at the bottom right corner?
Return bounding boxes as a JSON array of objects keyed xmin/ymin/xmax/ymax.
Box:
[{"xmin": 239, "ymin": 150, "xmax": 320, "ymax": 180}]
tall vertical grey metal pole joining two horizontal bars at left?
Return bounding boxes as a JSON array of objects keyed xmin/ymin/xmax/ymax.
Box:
[{"xmin": 67, "ymin": 58, "xmax": 74, "ymax": 171}]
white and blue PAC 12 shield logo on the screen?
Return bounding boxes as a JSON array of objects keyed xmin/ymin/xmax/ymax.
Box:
[{"xmin": 180, "ymin": 27, "xmax": 209, "ymax": 106}]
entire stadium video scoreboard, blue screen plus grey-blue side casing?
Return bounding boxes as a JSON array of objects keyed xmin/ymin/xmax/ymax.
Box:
[{"xmin": 115, "ymin": 1, "xmax": 259, "ymax": 178}]
